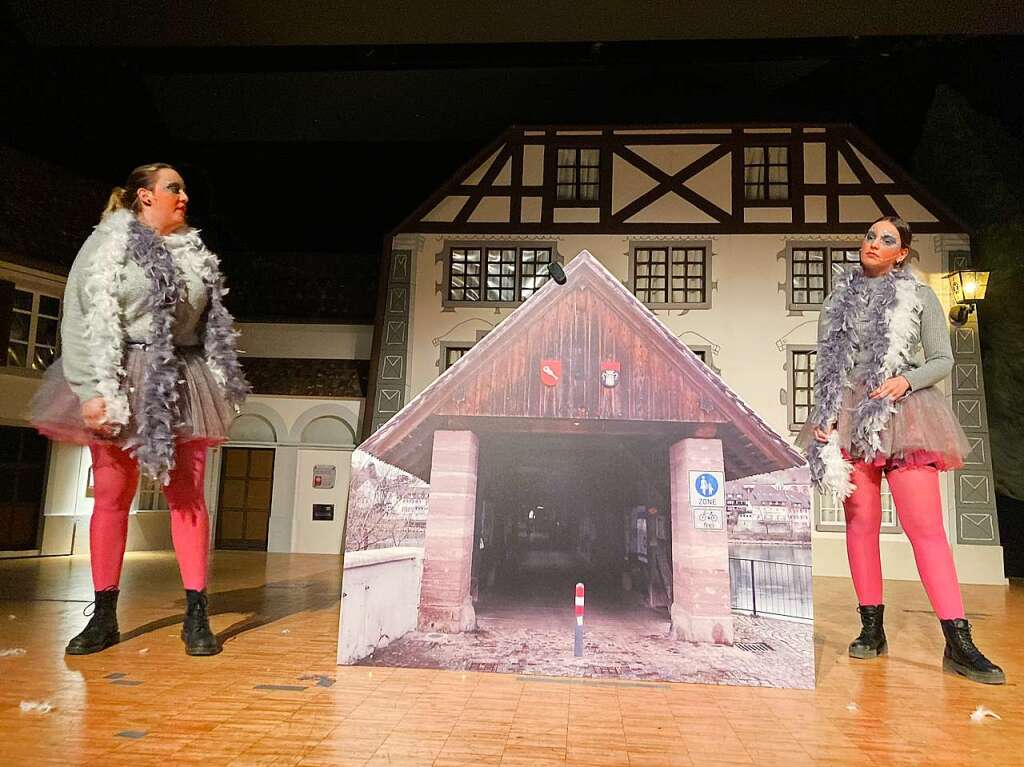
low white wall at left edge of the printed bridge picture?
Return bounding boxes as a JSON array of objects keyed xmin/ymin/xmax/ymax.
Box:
[{"xmin": 338, "ymin": 548, "xmax": 423, "ymax": 666}]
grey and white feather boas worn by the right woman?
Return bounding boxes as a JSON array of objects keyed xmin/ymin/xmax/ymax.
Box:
[{"xmin": 807, "ymin": 268, "xmax": 921, "ymax": 499}]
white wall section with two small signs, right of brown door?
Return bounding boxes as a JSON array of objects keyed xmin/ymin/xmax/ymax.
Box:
[{"xmin": 292, "ymin": 449, "xmax": 352, "ymax": 554}]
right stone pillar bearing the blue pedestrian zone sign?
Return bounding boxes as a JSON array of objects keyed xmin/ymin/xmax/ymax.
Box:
[{"xmin": 669, "ymin": 439, "xmax": 733, "ymax": 644}]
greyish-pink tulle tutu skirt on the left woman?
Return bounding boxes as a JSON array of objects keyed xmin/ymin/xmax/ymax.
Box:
[{"xmin": 31, "ymin": 346, "xmax": 234, "ymax": 446}]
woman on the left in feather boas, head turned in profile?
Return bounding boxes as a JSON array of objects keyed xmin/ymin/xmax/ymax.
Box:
[{"xmin": 33, "ymin": 163, "xmax": 248, "ymax": 655}]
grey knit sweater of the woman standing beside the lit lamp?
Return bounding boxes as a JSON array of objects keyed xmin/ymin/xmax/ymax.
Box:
[{"xmin": 818, "ymin": 279, "xmax": 953, "ymax": 391}]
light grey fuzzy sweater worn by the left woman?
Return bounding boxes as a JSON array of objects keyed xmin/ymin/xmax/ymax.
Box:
[{"xmin": 60, "ymin": 224, "xmax": 209, "ymax": 402}]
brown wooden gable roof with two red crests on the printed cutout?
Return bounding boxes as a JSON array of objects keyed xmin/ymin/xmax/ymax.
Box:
[{"xmin": 360, "ymin": 251, "xmax": 804, "ymax": 481}]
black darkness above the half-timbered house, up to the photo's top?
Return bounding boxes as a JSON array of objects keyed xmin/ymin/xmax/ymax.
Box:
[{"xmin": 0, "ymin": 0, "xmax": 1024, "ymax": 314}]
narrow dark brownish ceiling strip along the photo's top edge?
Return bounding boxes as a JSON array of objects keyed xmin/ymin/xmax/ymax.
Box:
[{"xmin": 7, "ymin": 0, "xmax": 1024, "ymax": 46}]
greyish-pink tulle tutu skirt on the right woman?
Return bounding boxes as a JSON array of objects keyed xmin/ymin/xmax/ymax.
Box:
[{"xmin": 797, "ymin": 384, "xmax": 971, "ymax": 471}]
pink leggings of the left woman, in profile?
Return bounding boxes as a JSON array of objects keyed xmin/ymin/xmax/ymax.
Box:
[{"xmin": 89, "ymin": 441, "xmax": 210, "ymax": 591}]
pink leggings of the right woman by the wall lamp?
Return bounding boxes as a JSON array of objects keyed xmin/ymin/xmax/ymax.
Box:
[{"xmin": 844, "ymin": 461, "xmax": 964, "ymax": 620}]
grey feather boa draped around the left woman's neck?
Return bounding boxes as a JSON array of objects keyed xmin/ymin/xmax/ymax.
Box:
[{"xmin": 116, "ymin": 217, "xmax": 250, "ymax": 484}]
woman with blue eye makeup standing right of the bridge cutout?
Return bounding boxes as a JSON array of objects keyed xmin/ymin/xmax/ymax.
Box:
[{"xmin": 798, "ymin": 216, "xmax": 1006, "ymax": 684}]
